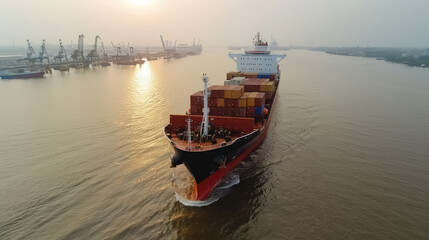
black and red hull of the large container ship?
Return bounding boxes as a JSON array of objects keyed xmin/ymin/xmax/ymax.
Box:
[{"xmin": 169, "ymin": 87, "xmax": 277, "ymax": 201}]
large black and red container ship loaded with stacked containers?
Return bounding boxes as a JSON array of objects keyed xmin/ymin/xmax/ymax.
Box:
[{"xmin": 164, "ymin": 33, "xmax": 286, "ymax": 201}]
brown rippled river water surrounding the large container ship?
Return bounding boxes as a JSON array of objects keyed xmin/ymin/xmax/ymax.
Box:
[{"xmin": 0, "ymin": 49, "xmax": 429, "ymax": 239}]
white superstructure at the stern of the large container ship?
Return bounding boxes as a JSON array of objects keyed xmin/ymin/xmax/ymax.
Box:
[{"xmin": 228, "ymin": 33, "xmax": 286, "ymax": 74}]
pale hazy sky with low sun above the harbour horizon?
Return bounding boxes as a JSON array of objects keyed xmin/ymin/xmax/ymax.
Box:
[{"xmin": 0, "ymin": 0, "xmax": 429, "ymax": 47}]
